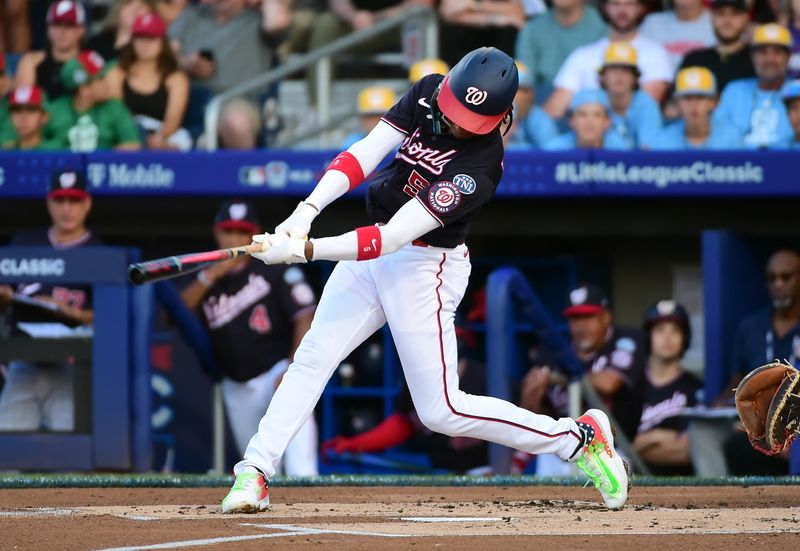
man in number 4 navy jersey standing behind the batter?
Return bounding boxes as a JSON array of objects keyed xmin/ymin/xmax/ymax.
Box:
[{"xmin": 181, "ymin": 201, "xmax": 319, "ymax": 476}]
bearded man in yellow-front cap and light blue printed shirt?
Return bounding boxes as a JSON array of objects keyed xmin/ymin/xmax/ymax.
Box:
[{"xmin": 713, "ymin": 23, "xmax": 794, "ymax": 149}]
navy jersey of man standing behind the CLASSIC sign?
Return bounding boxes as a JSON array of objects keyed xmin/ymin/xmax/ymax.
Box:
[{"xmin": 9, "ymin": 229, "xmax": 103, "ymax": 322}]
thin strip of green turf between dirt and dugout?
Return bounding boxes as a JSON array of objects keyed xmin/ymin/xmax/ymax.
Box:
[{"xmin": 0, "ymin": 473, "xmax": 800, "ymax": 488}]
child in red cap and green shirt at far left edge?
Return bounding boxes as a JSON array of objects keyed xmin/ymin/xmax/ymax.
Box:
[{"xmin": 2, "ymin": 86, "xmax": 57, "ymax": 151}]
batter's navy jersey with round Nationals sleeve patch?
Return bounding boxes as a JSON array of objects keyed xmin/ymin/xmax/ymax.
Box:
[{"xmin": 367, "ymin": 75, "xmax": 503, "ymax": 248}]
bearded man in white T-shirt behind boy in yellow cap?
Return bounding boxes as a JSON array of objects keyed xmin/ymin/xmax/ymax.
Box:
[{"xmin": 544, "ymin": 0, "xmax": 673, "ymax": 119}]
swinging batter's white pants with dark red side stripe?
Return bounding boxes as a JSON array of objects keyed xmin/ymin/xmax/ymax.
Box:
[{"xmin": 234, "ymin": 245, "xmax": 582, "ymax": 478}]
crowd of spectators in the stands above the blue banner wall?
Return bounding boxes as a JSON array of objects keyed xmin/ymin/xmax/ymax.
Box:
[{"xmin": 0, "ymin": 0, "xmax": 800, "ymax": 151}]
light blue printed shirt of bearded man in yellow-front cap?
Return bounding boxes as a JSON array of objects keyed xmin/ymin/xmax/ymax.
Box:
[{"xmin": 712, "ymin": 78, "xmax": 794, "ymax": 149}]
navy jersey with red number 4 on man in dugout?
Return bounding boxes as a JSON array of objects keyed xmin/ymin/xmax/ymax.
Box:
[{"xmin": 200, "ymin": 261, "xmax": 315, "ymax": 382}]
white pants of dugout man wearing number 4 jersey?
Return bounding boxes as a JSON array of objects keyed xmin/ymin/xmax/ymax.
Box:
[{"xmin": 222, "ymin": 360, "xmax": 319, "ymax": 476}]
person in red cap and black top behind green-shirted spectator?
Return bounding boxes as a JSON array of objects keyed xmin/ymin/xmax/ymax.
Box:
[{"xmin": 16, "ymin": 0, "xmax": 86, "ymax": 101}]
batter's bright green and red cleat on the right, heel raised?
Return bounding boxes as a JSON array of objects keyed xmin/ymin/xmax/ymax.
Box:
[{"xmin": 575, "ymin": 409, "xmax": 629, "ymax": 509}]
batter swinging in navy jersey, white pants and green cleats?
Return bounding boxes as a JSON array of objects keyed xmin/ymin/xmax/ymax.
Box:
[{"xmin": 222, "ymin": 48, "xmax": 628, "ymax": 513}]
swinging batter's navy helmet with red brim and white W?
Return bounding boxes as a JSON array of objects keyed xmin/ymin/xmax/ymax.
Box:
[{"xmin": 431, "ymin": 48, "xmax": 519, "ymax": 134}]
